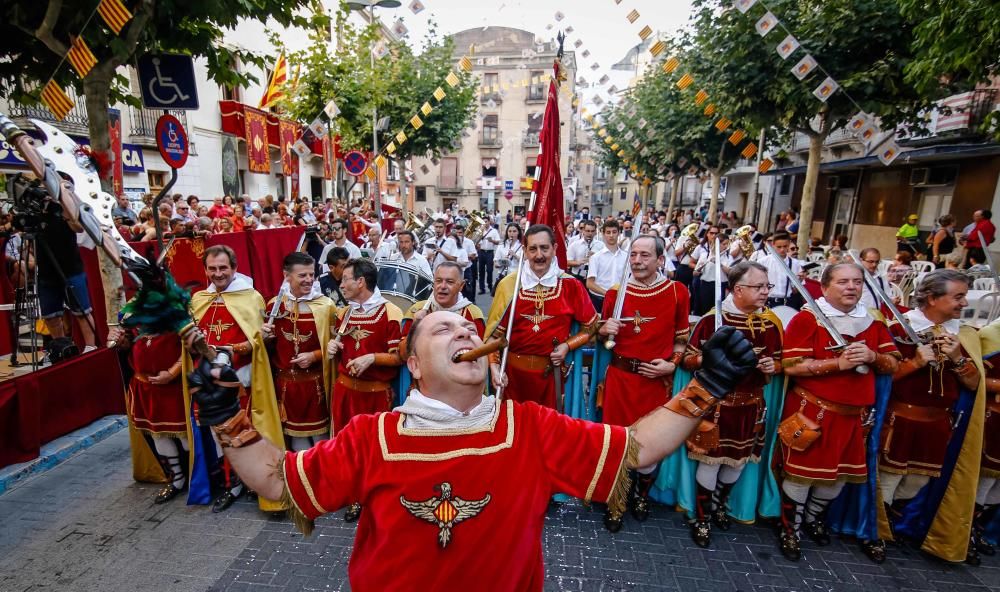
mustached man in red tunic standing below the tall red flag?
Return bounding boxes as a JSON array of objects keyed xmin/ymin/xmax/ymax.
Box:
[{"xmin": 486, "ymin": 224, "xmax": 598, "ymax": 408}]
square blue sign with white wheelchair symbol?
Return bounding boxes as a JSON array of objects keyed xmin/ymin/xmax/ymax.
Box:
[{"xmin": 139, "ymin": 53, "xmax": 198, "ymax": 111}]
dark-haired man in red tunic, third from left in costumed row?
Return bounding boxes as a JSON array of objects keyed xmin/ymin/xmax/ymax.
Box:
[{"xmin": 261, "ymin": 252, "xmax": 334, "ymax": 450}]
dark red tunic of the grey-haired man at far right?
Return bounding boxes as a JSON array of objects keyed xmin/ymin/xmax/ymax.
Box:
[{"xmin": 879, "ymin": 325, "xmax": 960, "ymax": 477}]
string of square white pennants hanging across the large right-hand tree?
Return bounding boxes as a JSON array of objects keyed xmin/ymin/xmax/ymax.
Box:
[{"xmin": 733, "ymin": 0, "xmax": 899, "ymax": 166}]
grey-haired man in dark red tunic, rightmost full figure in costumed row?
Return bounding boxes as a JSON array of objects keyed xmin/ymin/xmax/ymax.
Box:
[{"xmin": 879, "ymin": 269, "xmax": 979, "ymax": 562}]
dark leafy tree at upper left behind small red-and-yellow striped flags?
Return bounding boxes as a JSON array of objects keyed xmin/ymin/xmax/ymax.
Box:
[{"xmin": 0, "ymin": 0, "xmax": 303, "ymax": 319}]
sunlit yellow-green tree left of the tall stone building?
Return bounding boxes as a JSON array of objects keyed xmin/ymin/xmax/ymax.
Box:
[{"xmin": 272, "ymin": 6, "xmax": 477, "ymax": 206}]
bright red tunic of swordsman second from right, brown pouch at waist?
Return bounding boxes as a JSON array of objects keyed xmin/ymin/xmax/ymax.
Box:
[{"xmin": 782, "ymin": 310, "xmax": 898, "ymax": 484}]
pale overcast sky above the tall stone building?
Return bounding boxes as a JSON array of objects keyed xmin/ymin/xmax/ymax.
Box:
[{"xmin": 392, "ymin": 0, "xmax": 691, "ymax": 107}]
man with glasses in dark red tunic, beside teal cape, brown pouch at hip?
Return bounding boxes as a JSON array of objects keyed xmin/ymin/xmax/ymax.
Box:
[{"xmin": 681, "ymin": 261, "xmax": 781, "ymax": 547}]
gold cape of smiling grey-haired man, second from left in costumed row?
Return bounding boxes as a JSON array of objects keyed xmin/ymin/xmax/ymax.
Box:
[{"xmin": 183, "ymin": 289, "xmax": 286, "ymax": 512}]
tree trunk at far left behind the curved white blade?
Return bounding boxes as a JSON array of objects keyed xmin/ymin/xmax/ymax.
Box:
[{"xmin": 83, "ymin": 71, "xmax": 125, "ymax": 323}]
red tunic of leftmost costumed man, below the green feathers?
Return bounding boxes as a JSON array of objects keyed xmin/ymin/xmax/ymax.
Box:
[{"xmin": 129, "ymin": 333, "xmax": 187, "ymax": 437}]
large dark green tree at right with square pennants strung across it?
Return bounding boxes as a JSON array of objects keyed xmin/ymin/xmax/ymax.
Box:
[{"xmin": 684, "ymin": 0, "xmax": 941, "ymax": 252}]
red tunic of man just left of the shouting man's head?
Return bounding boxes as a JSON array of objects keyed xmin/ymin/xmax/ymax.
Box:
[{"xmin": 331, "ymin": 302, "xmax": 402, "ymax": 432}]
